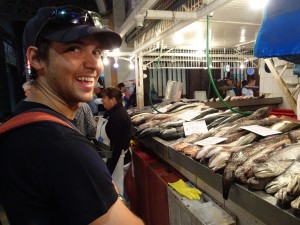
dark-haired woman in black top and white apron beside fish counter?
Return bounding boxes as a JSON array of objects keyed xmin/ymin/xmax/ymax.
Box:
[{"xmin": 98, "ymin": 87, "xmax": 132, "ymax": 193}]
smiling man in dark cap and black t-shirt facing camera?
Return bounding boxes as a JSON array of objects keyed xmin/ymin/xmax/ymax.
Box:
[{"xmin": 0, "ymin": 6, "xmax": 143, "ymax": 225}]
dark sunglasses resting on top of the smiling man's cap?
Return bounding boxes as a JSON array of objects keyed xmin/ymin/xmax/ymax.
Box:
[{"xmin": 34, "ymin": 5, "xmax": 103, "ymax": 46}]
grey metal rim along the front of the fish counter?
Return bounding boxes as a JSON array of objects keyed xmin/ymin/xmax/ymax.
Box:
[{"xmin": 136, "ymin": 134, "xmax": 300, "ymax": 225}]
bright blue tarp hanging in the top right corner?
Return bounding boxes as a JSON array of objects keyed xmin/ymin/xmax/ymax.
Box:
[{"xmin": 254, "ymin": 0, "xmax": 300, "ymax": 63}]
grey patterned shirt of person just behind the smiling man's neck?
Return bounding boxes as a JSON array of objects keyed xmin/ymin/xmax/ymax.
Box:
[{"xmin": 73, "ymin": 102, "xmax": 96, "ymax": 140}]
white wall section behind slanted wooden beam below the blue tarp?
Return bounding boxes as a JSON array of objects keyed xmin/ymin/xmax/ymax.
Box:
[{"xmin": 259, "ymin": 58, "xmax": 300, "ymax": 109}]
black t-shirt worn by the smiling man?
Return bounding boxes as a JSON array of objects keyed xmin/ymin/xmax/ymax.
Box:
[{"xmin": 0, "ymin": 102, "xmax": 118, "ymax": 225}]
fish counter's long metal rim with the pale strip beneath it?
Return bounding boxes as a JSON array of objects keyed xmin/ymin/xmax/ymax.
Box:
[{"xmin": 139, "ymin": 137, "xmax": 300, "ymax": 225}]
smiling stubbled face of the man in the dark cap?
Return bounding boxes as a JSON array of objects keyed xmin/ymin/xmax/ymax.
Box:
[{"xmin": 39, "ymin": 37, "xmax": 103, "ymax": 105}]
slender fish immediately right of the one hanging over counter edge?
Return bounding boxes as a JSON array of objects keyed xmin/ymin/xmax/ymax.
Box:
[{"xmin": 234, "ymin": 136, "xmax": 291, "ymax": 183}]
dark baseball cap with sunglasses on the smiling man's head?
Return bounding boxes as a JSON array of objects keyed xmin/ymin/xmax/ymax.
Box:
[{"xmin": 23, "ymin": 5, "xmax": 122, "ymax": 50}]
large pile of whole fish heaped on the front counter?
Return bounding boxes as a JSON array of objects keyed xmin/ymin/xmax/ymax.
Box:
[{"xmin": 131, "ymin": 102, "xmax": 300, "ymax": 213}]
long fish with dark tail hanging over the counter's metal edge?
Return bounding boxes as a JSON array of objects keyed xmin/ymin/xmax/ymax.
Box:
[{"xmin": 222, "ymin": 134, "xmax": 286, "ymax": 200}]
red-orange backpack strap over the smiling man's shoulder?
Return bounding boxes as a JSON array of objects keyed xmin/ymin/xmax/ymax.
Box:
[{"xmin": 0, "ymin": 112, "xmax": 74, "ymax": 134}]
